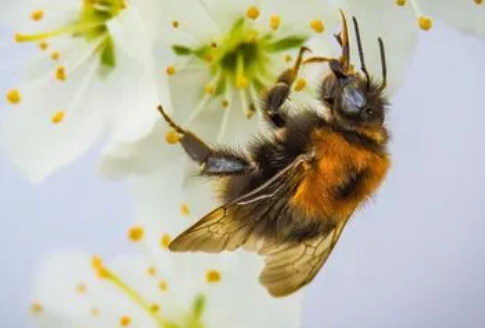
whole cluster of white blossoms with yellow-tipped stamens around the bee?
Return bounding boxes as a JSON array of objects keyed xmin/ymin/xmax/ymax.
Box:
[{"xmin": 0, "ymin": 0, "xmax": 485, "ymax": 328}]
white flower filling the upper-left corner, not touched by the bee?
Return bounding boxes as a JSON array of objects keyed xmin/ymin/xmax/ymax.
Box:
[{"xmin": 0, "ymin": 0, "xmax": 166, "ymax": 182}]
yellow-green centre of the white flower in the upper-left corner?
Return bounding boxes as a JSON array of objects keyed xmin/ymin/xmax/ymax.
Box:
[{"xmin": 15, "ymin": 0, "xmax": 126, "ymax": 68}]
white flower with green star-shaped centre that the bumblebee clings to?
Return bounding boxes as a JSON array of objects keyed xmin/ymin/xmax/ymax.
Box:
[{"xmin": 160, "ymin": 0, "xmax": 338, "ymax": 141}]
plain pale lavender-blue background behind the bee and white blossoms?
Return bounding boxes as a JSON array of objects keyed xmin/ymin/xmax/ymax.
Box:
[{"xmin": 0, "ymin": 26, "xmax": 485, "ymax": 328}]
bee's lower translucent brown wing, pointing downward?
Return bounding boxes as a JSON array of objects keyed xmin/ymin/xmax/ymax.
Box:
[{"xmin": 259, "ymin": 220, "xmax": 347, "ymax": 297}]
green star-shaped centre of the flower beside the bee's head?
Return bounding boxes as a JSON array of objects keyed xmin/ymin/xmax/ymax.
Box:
[{"xmin": 172, "ymin": 18, "xmax": 307, "ymax": 96}]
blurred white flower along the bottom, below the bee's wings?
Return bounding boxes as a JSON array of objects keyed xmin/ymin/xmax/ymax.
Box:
[{"xmin": 30, "ymin": 252, "xmax": 301, "ymax": 328}]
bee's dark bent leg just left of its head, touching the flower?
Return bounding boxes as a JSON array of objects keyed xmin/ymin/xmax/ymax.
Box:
[{"xmin": 264, "ymin": 47, "xmax": 310, "ymax": 128}]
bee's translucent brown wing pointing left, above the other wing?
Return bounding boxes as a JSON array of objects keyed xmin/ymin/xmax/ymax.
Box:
[{"xmin": 169, "ymin": 155, "xmax": 311, "ymax": 253}]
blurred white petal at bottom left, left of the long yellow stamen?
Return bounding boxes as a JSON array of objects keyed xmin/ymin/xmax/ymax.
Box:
[{"xmin": 32, "ymin": 252, "xmax": 158, "ymax": 328}]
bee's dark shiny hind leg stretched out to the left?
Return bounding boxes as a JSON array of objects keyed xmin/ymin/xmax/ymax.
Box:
[{"xmin": 158, "ymin": 105, "xmax": 254, "ymax": 175}]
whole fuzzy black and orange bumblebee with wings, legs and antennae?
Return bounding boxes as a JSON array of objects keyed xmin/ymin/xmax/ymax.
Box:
[{"xmin": 158, "ymin": 13, "xmax": 390, "ymax": 297}]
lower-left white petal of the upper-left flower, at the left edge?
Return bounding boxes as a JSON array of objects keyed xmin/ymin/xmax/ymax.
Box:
[{"xmin": 0, "ymin": 58, "xmax": 103, "ymax": 182}]
